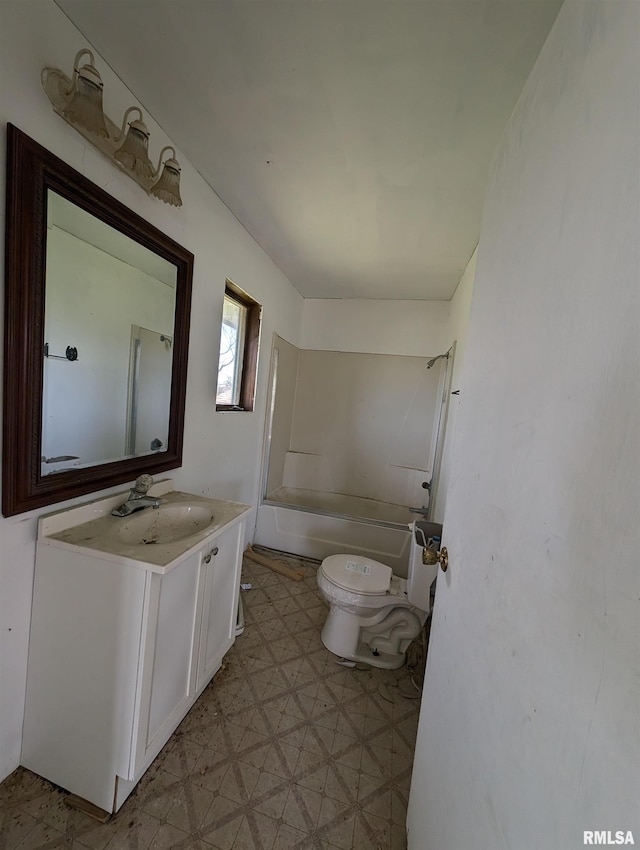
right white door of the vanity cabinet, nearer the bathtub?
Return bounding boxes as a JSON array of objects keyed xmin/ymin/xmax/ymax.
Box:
[{"xmin": 196, "ymin": 522, "xmax": 244, "ymax": 693}]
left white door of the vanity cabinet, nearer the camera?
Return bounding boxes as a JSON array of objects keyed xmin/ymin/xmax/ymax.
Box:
[{"xmin": 134, "ymin": 555, "xmax": 199, "ymax": 774}]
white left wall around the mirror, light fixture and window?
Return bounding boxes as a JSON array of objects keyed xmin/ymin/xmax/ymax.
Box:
[{"xmin": 0, "ymin": 0, "xmax": 303, "ymax": 778}]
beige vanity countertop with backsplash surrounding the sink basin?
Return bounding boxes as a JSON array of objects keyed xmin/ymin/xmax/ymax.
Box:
[{"xmin": 38, "ymin": 482, "xmax": 252, "ymax": 573}]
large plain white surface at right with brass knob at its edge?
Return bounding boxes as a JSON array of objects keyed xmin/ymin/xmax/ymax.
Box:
[{"xmin": 408, "ymin": 0, "xmax": 640, "ymax": 850}]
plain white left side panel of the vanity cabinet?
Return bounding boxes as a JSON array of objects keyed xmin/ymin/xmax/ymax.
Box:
[{"xmin": 22, "ymin": 540, "xmax": 151, "ymax": 816}]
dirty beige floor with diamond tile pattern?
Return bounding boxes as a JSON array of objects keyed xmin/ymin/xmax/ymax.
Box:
[{"xmin": 0, "ymin": 553, "xmax": 430, "ymax": 850}]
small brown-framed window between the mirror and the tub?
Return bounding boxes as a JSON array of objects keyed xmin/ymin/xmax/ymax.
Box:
[{"xmin": 216, "ymin": 281, "xmax": 262, "ymax": 410}]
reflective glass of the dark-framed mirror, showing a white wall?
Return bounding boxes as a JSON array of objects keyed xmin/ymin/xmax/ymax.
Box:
[{"xmin": 41, "ymin": 189, "xmax": 177, "ymax": 475}]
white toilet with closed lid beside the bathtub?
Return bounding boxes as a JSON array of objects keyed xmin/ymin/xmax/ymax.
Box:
[{"xmin": 317, "ymin": 523, "xmax": 438, "ymax": 670}]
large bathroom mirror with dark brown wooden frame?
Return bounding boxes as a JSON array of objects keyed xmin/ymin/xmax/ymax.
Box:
[{"xmin": 2, "ymin": 125, "xmax": 193, "ymax": 516}]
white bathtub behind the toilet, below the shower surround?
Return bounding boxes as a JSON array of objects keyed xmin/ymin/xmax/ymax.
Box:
[{"xmin": 254, "ymin": 487, "xmax": 416, "ymax": 578}]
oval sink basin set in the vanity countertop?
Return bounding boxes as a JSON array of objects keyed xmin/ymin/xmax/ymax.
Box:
[{"xmin": 116, "ymin": 503, "xmax": 215, "ymax": 545}]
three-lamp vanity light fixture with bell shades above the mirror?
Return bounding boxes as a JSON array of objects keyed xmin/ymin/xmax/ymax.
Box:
[{"xmin": 42, "ymin": 48, "xmax": 182, "ymax": 207}]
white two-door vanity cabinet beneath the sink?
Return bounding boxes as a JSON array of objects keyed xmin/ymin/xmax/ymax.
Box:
[{"xmin": 22, "ymin": 480, "xmax": 250, "ymax": 812}]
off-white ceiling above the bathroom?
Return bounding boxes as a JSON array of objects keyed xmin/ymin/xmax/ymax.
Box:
[{"xmin": 56, "ymin": 0, "xmax": 561, "ymax": 300}]
